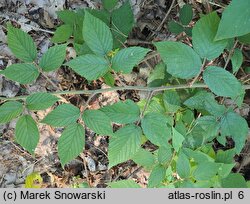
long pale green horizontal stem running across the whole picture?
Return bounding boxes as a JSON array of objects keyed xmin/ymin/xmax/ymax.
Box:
[{"xmin": 0, "ymin": 83, "xmax": 250, "ymax": 101}]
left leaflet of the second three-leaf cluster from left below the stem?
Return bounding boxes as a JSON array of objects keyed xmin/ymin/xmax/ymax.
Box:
[{"xmin": 41, "ymin": 104, "xmax": 80, "ymax": 127}]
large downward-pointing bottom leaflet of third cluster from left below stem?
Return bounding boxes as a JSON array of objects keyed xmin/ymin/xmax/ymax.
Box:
[{"xmin": 108, "ymin": 125, "xmax": 142, "ymax": 169}]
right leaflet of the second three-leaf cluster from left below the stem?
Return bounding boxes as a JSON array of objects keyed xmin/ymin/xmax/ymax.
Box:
[{"xmin": 82, "ymin": 110, "xmax": 113, "ymax": 136}]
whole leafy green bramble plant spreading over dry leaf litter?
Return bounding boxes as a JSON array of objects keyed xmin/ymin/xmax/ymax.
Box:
[{"xmin": 0, "ymin": 0, "xmax": 250, "ymax": 188}]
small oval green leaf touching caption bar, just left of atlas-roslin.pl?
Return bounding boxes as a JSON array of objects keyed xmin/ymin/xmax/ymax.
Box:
[{"xmin": 148, "ymin": 165, "xmax": 166, "ymax": 188}]
